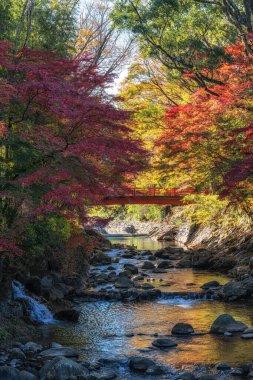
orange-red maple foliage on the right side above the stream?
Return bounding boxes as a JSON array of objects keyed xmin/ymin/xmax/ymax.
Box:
[{"xmin": 159, "ymin": 38, "xmax": 253, "ymax": 198}]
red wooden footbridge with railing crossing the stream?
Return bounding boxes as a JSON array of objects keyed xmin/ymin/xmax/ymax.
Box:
[{"xmin": 99, "ymin": 186, "xmax": 196, "ymax": 206}]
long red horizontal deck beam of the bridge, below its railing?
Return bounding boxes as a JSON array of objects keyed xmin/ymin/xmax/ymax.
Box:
[{"xmin": 99, "ymin": 196, "xmax": 184, "ymax": 206}]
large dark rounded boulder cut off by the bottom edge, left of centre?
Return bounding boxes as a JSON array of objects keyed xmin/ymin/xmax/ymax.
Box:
[{"xmin": 40, "ymin": 357, "xmax": 89, "ymax": 380}]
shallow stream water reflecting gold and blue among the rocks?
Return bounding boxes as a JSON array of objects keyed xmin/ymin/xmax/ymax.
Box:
[{"xmin": 49, "ymin": 238, "xmax": 253, "ymax": 368}]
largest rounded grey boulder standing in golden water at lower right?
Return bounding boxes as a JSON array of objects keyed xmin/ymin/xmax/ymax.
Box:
[{"xmin": 210, "ymin": 314, "xmax": 247, "ymax": 334}]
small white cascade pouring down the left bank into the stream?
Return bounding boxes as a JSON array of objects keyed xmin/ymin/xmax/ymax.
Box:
[{"xmin": 12, "ymin": 280, "xmax": 54, "ymax": 323}]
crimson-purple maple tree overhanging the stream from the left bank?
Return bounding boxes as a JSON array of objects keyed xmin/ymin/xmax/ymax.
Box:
[{"xmin": 0, "ymin": 42, "xmax": 145, "ymax": 253}]
